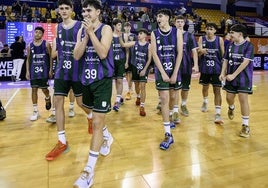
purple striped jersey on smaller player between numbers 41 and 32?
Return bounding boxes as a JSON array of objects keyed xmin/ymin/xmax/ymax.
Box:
[{"xmin": 131, "ymin": 41, "xmax": 149, "ymax": 72}]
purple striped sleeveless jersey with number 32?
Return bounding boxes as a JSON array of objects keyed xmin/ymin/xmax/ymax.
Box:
[{"xmin": 153, "ymin": 27, "xmax": 181, "ymax": 81}]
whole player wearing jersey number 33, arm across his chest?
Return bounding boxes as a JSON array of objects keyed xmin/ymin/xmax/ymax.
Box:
[{"xmin": 198, "ymin": 23, "xmax": 224, "ymax": 124}]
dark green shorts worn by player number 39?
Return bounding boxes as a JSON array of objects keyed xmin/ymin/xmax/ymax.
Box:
[{"xmin": 83, "ymin": 78, "xmax": 113, "ymax": 113}]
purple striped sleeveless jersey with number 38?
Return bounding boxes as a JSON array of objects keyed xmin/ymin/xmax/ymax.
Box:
[{"xmin": 55, "ymin": 21, "xmax": 81, "ymax": 82}]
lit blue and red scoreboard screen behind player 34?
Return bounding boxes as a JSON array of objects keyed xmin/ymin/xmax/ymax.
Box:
[{"xmin": 6, "ymin": 22, "xmax": 57, "ymax": 46}]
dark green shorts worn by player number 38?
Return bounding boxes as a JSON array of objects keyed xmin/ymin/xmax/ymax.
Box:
[{"xmin": 54, "ymin": 79, "xmax": 83, "ymax": 97}]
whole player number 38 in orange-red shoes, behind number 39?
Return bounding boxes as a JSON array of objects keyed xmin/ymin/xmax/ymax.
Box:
[{"xmin": 46, "ymin": 0, "xmax": 92, "ymax": 161}]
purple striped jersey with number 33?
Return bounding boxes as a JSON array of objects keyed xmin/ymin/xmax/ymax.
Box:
[{"xmin": 199, "ymin": 36, "xmax": 223, "ymax": 74}]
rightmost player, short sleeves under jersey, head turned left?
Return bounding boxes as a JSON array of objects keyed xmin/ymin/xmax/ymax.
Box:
[{"xmin": 219, "ymin": 24, "xmax": 254, "ymax": 138}]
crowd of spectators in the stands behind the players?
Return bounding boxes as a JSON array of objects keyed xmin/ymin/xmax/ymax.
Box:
[{"xmin": 0, "ymin": 0, "xmax": 264, "ymax": 34}]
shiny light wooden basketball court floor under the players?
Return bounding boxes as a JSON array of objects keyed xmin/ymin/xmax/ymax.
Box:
[{"xmin": 0, "ymin": 72, "xmax": 268, "ymax": 188}]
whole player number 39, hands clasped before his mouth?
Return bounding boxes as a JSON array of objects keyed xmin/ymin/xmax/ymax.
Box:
[{"xmin": 74, "ymin": 0, "xmax": 114, "ymax": 188}]
